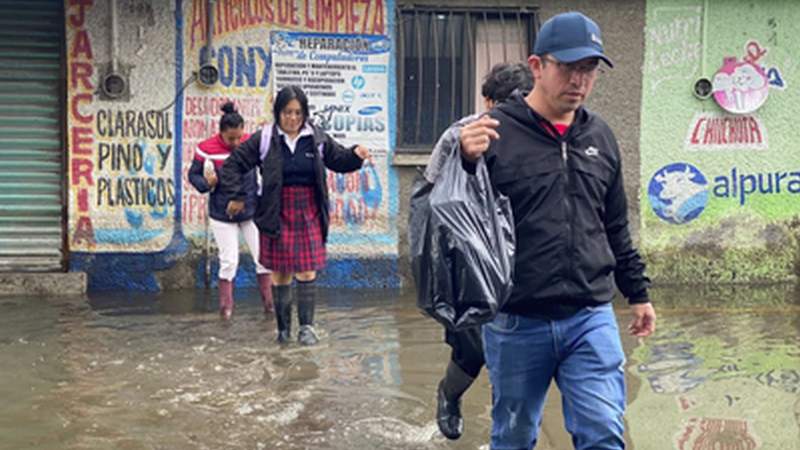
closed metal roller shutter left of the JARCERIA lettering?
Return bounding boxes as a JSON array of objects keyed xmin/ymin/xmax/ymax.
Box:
[{"xmin": 0, "ymin": 0, "xmax": 65, "ymax": 271}]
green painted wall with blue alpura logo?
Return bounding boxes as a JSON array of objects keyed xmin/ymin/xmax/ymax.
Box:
[{"xmin": 640, "ymin": 0, "xmax": 800, "ymax": 283}]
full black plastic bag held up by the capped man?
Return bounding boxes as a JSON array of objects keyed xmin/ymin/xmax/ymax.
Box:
[{"xmin": 408, "ymin": 150, "xmax": 515, "ymax": 331}]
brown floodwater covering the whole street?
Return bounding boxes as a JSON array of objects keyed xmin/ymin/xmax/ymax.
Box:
[{"xmin": 0, "ymin": 286, "xmax": 800, "ymax": 450}]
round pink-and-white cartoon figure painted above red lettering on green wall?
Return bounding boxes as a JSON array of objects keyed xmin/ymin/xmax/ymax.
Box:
[{"xmin": 713, "ymin": 58, "xmax": 769, "ymax": 114}]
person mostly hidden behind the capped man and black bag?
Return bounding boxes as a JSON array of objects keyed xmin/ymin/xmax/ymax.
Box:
[{"xmin": 424, "ymin": 63, "xmax": 533, "ymax": 439}]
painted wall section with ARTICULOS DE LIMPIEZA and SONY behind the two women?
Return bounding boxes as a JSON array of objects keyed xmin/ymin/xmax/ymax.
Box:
[{"xmin": 178, "ymin": 0, "xmax": 399, "ymax": 286}]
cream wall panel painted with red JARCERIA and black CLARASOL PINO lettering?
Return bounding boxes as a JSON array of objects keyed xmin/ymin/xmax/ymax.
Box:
[{"xmin": 67, "ymin": 1, "xmax": 176, "ymax": 253}]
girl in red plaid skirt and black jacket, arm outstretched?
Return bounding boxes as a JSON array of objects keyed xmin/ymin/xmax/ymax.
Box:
[{"xmin": 222, "ymin": 86, "xmax": 369, "ymax": 345}]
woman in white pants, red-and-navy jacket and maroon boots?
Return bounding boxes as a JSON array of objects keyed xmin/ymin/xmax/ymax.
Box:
[{"xmin": 189, "ymin": 102, "xmax": 274, "ymax": 320}]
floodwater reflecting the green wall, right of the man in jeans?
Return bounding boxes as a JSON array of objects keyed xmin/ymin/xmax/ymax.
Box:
[{"xmin": 629, "ymin": 286, "xmax": 800, "ymax": 450}]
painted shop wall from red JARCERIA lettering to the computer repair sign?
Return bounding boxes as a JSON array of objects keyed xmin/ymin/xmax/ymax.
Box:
[{"xmin": 65, "ymin": 0, "xmax": 399, "ymax": 290}]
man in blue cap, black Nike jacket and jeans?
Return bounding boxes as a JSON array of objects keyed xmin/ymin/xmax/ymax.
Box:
[{"xmin": 460, "ymin": 12, "xmax": 656, "ymax": 450}]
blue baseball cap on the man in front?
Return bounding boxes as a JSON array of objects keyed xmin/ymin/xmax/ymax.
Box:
[{"xmin": 533, "ymin": 12, "xmax": 614, "ymax": 67}]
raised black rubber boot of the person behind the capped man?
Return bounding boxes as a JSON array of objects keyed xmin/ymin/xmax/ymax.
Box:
[{"xmin": 436, "ymin": 361, "xmax": 475, "ymax": 439}]
